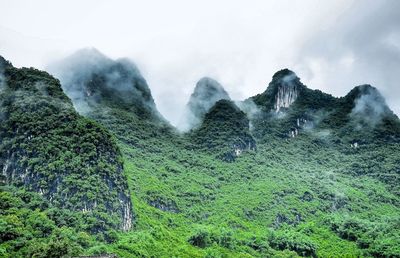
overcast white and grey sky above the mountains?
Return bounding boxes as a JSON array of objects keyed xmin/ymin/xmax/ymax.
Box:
[{"xmin": 0, "ymin": 0, "xmax": 400, "ymax": 124}]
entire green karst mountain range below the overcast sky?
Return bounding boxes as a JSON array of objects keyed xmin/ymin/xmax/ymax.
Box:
[{"xmin": 0, "ymin": 55, "xmax": 400, "ymax": 257}]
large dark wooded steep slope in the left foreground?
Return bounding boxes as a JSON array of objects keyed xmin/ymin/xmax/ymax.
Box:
[{"xmin": 0, "ymin": 58, "xmax": 133, "ymax": 232}]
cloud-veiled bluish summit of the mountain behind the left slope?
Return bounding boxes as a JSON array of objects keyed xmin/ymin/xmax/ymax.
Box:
[{"xmin": 50, "ymin": 48, "xmax": 158, "ymax": 117}]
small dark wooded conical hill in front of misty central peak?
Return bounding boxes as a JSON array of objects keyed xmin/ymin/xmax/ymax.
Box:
[{"xmin": 191, "ymin": 99, "xmax": 256, "ymax": 161}]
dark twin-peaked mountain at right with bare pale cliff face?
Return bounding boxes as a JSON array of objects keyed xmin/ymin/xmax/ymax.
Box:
[{"xmin": 250, "ymin": 69, "xmax": 400, "ymax": 145}]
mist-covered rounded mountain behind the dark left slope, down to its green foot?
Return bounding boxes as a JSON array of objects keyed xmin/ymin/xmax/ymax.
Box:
[{"xmin": 49, "ymin": 49, "xmax": 173, "ymax": 149}]
